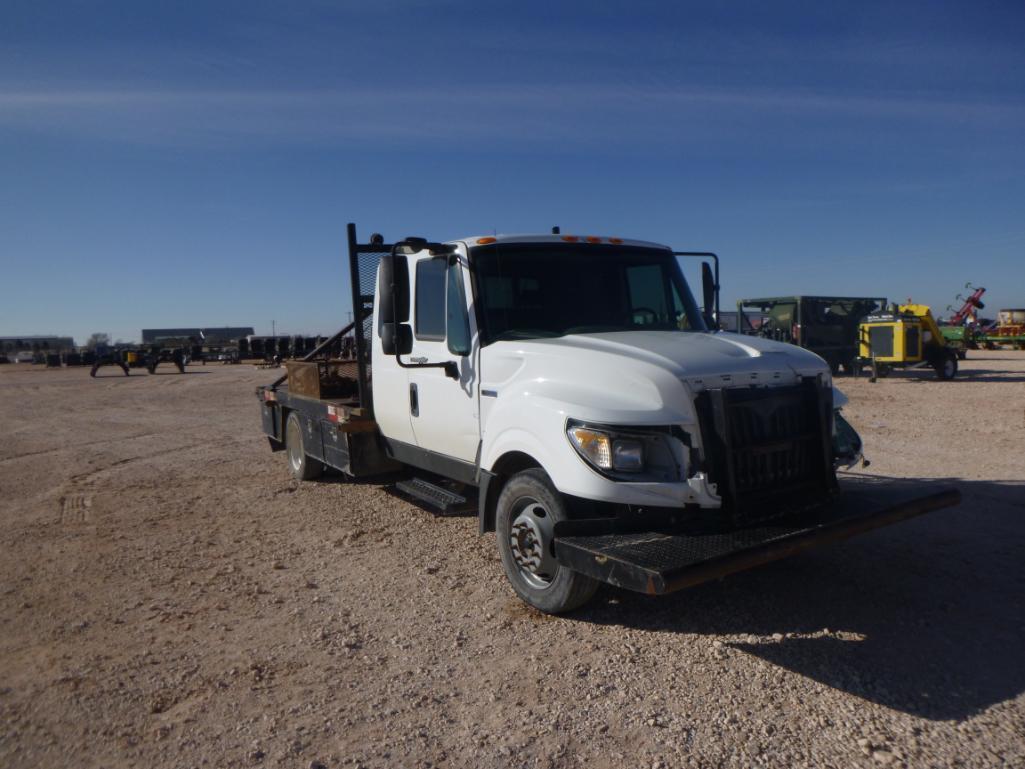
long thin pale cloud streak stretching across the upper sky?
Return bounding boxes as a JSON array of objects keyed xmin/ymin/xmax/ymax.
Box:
[{"xmin": 0, "ymin": 84, "xmax": 1025, "ymax": 150}]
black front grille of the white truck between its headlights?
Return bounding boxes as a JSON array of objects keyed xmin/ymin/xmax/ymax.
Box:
[{"xmin": 696, "ymin": 377, "xmax": 836, "ymax": 525}]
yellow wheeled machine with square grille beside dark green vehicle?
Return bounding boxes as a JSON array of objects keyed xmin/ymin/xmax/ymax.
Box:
[{"xmin": 858, "ymin": 305, "xmax": 957, "ymax": 381}]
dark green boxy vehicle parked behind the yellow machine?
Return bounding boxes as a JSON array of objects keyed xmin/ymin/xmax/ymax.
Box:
[{"xmin": 737, "ymin": 296, "xmax": 887, "ymax": 374}]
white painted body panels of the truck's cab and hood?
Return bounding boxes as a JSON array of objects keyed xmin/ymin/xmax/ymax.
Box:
[{"xmin": 372, "ymin": 236, "xmax": 842, "ymax": 508}]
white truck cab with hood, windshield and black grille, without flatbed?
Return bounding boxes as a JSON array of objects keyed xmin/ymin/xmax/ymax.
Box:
[{"xmin": 371, "ymin": 235, "xmax": 857, "ymax": 603}]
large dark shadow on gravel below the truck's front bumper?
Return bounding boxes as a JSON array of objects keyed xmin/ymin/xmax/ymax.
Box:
[{"xmin": 574, "ymin": 480, "xmax": 1025, "ymax": 720}]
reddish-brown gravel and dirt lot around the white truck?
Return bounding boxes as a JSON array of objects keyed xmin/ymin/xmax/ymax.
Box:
[{"xmin": 0, "ymin": 352, "xmax": 1025, "ymax": 769}]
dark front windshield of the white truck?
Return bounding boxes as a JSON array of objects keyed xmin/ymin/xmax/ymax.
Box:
[{"xmin": 473, "ymin": 243, "xmax": 705, "ymax": 343}]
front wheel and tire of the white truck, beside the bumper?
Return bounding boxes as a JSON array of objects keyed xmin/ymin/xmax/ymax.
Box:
[{"xmin": 495, "ymin": 469, "xmax": 599, "ymax": 614}]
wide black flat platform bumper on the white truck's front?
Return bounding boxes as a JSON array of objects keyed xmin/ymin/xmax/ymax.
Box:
[{"xmin": 556, "ymin": 476, "xmax": 960, "ymax": 595}]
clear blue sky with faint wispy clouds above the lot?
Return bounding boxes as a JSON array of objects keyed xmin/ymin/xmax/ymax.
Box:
[{"xmin": 0, "ymin": 0, "xmax": 1025, "ymax": 341}]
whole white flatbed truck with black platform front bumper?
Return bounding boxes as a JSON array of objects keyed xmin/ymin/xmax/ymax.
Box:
[{"xmin": 256, "ymin": 225, "xmax": 959, "ymax": 613}]
